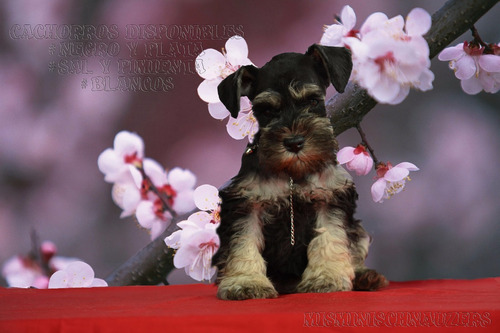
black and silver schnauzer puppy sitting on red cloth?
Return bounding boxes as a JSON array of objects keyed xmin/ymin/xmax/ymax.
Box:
[{"xmin": 213, "ymin": 45, "xmax": 387, "ymax": 300}]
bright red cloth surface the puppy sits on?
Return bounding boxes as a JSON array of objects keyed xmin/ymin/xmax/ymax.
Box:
[{"xmin": 0, "ymin": 278, "xmax": 500, "ymax": 333}]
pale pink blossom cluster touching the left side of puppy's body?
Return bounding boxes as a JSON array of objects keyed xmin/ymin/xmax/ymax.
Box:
[{"xmin": 165, "ymin": 185, "xmax": 220, "ymax": 281}]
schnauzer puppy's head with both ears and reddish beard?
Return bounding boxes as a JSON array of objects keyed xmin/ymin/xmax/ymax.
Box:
[{"xmin": 218, "ymin": 45, "xmax": 352, "ymax": 179}]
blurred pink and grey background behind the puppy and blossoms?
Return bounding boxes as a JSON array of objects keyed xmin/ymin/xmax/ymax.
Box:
[{"xmin": 0, "ymin": 0, "xmax": 500, "ymax": 283}]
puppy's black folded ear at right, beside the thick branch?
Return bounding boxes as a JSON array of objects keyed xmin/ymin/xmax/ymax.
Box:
[{"xmin": 306, "ymin": 44, "xmax": 352, "ymax": 93}]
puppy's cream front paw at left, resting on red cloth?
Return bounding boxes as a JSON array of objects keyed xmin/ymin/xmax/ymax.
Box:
[{"xmin": 217, "ymin": 276, "xmax": 278, "ymax": 300}]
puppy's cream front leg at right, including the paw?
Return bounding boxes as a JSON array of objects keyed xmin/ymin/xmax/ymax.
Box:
[{"xmin": 297, "ymin": 209, "xmax": 354, "ymax": 292}]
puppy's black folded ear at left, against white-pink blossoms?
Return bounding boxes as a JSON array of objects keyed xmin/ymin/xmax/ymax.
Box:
[{"xmin": 217, "ymin": 65, "xmax": 258, "ymax": 118}]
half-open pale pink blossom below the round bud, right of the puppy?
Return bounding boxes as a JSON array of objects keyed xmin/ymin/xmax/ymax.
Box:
[{"xmin": 371, "ymin": 162, "xmax": 419, "ymax": 202}]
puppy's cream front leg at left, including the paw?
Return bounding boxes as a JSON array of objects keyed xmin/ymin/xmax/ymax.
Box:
[{"xmin": 217, "ymin": 211, "xmax": 278, "ymax": 300}]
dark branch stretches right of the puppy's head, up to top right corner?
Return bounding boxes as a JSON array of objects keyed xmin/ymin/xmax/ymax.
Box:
[{"xmin": 326, "ymin": 0, "xmax": 499, "ymax": 135}]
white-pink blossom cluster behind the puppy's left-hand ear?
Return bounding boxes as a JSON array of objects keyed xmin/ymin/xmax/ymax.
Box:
[{"xmin": 195, "ymin": 36, "xmax": 258, "ymax": 142}]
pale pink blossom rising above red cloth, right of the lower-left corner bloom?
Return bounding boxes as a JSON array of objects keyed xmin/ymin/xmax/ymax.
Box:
[{"xmin": 49, "ymin": 261, "xmax": 108, "ymax": 289}]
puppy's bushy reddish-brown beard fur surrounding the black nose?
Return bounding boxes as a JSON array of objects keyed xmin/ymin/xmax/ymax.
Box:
[{"xmin": 259, "ymin": 115, "xmax": 338, "ymax": 180}]
